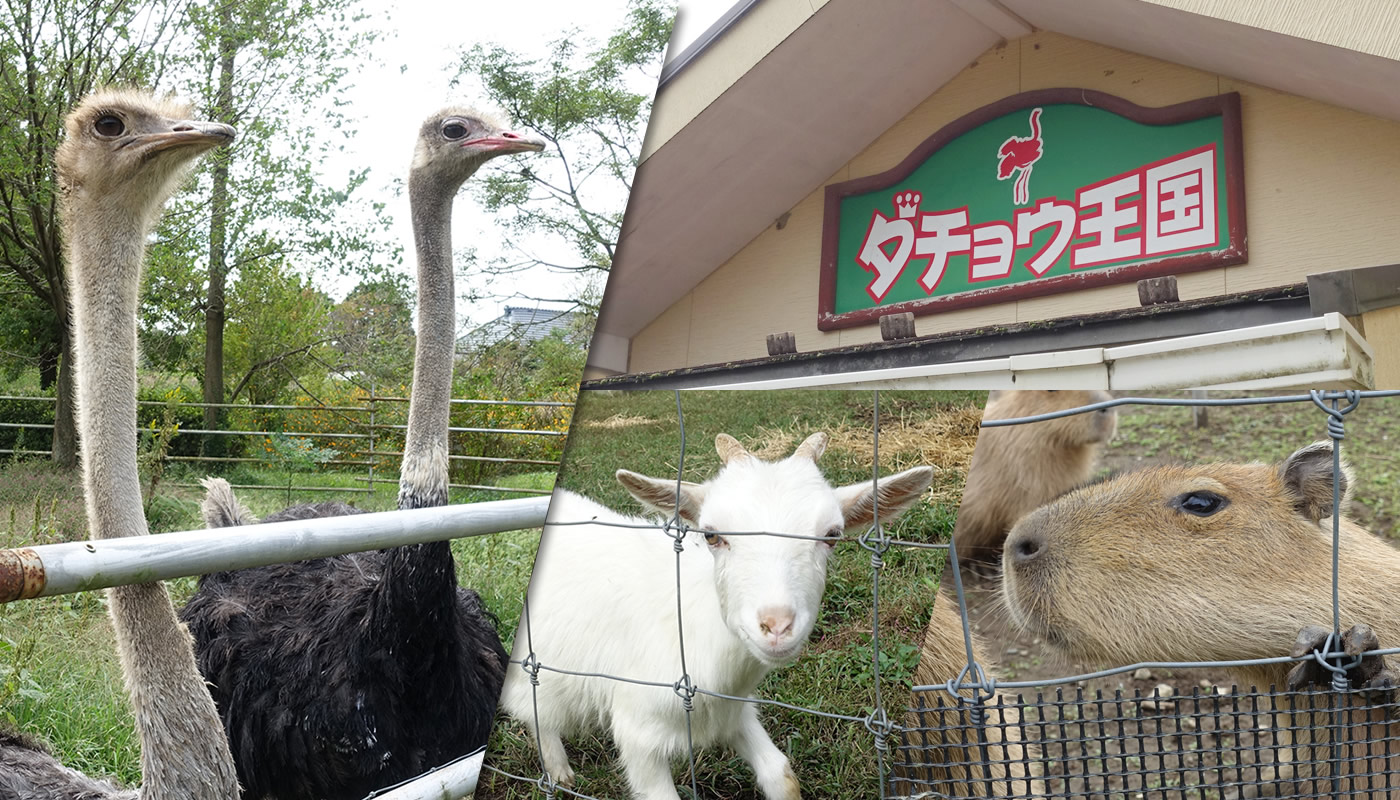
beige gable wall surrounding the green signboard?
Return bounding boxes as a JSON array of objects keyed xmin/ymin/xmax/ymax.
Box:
[{"xmin": 629, "ymin": 32, "xmax": 1400, "ymax": 371}]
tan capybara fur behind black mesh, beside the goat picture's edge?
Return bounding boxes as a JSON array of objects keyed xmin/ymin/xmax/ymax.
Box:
[{"xmin": 895, "ymin": 588, "xmax": 1044, "ymax": 797}]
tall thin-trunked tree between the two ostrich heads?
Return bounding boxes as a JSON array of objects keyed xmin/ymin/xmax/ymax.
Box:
[{"xmin": 160, "ymin": 0, "xmax": 398, "ymax": 445}]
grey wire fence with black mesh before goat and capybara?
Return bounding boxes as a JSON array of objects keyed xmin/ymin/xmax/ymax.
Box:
[{"xmin": 484, "ymin": 391, "xmax": 1400, "ymax": 800}]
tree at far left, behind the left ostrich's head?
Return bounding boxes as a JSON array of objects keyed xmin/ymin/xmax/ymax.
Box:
[{"xmin": 0, "ymin": 0, "xmax": 183, "ymax": 465}]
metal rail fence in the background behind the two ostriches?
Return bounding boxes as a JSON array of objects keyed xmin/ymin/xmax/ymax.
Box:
[{"xmin": 0, "ymin": 394, "xmax": 574, "ymax": 495}]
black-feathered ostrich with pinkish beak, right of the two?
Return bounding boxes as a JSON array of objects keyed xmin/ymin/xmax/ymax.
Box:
[{"xmin": 182, "ymin": 108, "xmax": 545, "ymax": 800}]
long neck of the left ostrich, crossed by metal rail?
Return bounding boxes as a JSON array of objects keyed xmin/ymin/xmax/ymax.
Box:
[{"xmin": 67, "ymin": 209, "xmax": 238, "ymax": 800}]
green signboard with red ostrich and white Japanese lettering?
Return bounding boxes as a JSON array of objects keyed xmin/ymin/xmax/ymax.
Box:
[{"xmin": 818, "ymin": 90, "xmax": 1246, "ymax": 331}]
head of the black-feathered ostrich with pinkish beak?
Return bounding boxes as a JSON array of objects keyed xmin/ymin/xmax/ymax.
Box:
[{"xmin": 412, "ymin": 106, "xmax": 545, "ymax": 192}]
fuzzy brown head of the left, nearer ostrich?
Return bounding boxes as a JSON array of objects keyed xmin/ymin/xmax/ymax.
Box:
[{"xmin": 55, "ymin": 90, "xmax": 234, "ymax": 227}]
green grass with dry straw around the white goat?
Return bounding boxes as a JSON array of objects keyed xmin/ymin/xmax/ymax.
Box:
[{"xmin": 477, "ymin": 391, "xmax": 984, "ymax": 800}]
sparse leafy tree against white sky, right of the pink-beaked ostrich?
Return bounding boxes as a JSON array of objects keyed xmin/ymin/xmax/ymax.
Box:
[{"xmin": 458, "ymin": 0, "xmax": 675, "ymax": 325}]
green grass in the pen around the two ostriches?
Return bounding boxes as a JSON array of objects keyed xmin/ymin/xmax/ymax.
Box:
[{"xmin": 0, "ymin": 460, "xmax": 554, "ymax": 785}]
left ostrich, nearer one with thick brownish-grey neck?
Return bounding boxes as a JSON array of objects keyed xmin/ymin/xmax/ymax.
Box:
[{"xmin": 0, "ymin": 91, "xmax": 238, "ymax": 800}]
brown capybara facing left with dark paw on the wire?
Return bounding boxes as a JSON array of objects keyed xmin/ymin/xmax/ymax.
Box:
[{"xmin": 1002, "ymin": 441, "xmax": 1400, "ymax": 799}]
